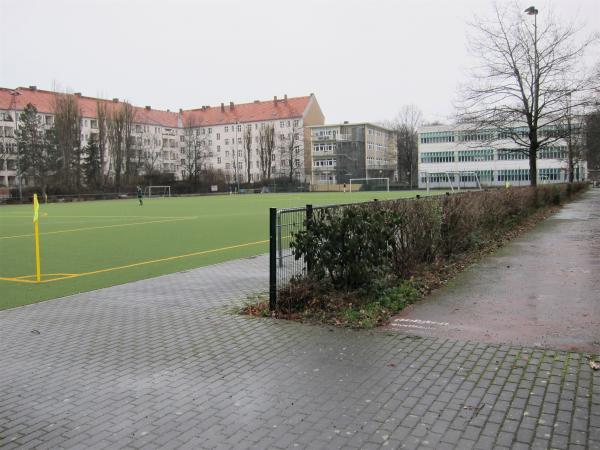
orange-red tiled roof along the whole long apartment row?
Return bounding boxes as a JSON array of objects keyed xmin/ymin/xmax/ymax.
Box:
[{"xmin": 0, "ymin": 87, "xmax": 310, "ymax": 127}]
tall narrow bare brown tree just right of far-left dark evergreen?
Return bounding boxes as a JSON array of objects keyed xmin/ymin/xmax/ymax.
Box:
[{"xmin": 53, "ymin": 94, "xmax": 81, "ymax": 189}]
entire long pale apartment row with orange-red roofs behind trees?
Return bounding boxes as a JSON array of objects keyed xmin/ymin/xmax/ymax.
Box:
[{"xmin": 0, "ymin": 86, "xmax": 324, "ymax": 187}]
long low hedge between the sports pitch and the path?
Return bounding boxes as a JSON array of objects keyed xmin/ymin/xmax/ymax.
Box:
[{"xmin": 291, "ymin": 183, "xmax": 587, "ymax": 291}]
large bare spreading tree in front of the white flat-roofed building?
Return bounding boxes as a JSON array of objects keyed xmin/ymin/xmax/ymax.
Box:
[{"xmin": 459, "ymin": 2, "xmax": 596, "ymax": 185}]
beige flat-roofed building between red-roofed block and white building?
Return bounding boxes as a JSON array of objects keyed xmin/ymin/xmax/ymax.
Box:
[{"xmin": 308, "ymin": 122, "xmax": 398, "ymax": 184}]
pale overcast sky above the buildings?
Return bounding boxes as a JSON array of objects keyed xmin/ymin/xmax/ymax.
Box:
[{"xmin": 0, "ymin": 0, "xmax": 600, "ymax": 122}]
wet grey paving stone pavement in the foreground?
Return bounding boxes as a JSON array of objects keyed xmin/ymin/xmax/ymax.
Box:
[{"xmin": 0, "ymin": 256, "xmax": 600, "ymax": 449}]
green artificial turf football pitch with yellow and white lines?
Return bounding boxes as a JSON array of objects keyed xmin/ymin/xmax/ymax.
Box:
[{"xmin": 0, "ymin": 191, "xmax": 424, "ymax": 309}]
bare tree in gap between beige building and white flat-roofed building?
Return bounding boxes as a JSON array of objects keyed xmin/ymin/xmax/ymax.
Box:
[{"xmin": 385, "ymin": 105, "xmax": 423, "ymax": 187}]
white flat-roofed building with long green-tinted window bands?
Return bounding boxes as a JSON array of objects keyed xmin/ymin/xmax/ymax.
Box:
[{"xmin": 419, "ymin": 124, "xmax": 587, "ymax": 188}]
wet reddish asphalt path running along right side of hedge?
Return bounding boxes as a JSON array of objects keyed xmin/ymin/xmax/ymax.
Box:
[{"xmin": 392, "ymin": 189, "xmax": 600, "ymax": 353}]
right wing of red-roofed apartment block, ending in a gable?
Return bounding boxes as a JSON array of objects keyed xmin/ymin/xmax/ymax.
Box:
[{"xmin": 181, "ymin": 94, "xmax": 325, "ymax": 182}]
